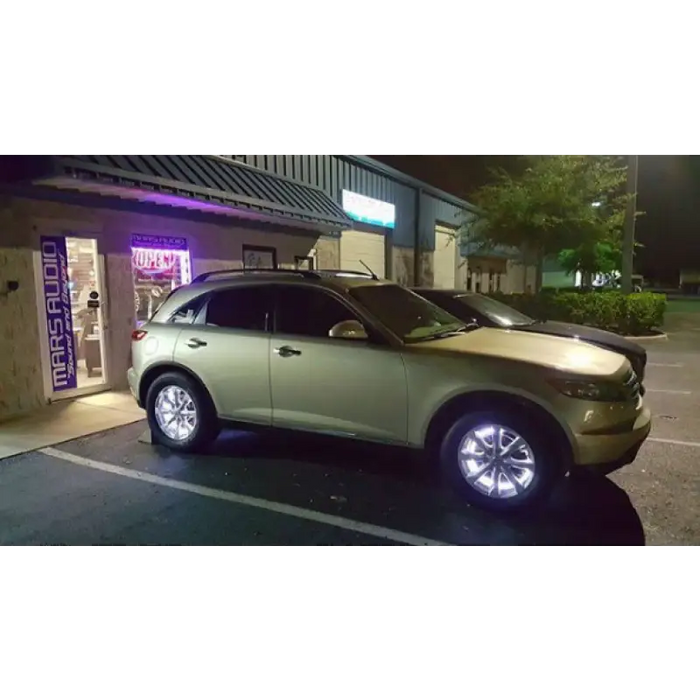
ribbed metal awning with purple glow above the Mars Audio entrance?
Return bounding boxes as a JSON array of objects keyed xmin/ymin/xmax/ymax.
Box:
[{"xmin": 2, "ymin": 151, "xmax": 353, "ymax": 230}]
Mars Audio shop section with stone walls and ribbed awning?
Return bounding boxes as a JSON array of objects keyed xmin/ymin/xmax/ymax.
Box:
[{"xmin": 0, "ymin": 152, "xmax": 353, "ymax": 420}]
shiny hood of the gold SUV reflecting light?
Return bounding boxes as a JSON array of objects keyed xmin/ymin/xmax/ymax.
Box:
[{"xmin": 410, "ymin": 328, "xmax": 627, "ymax": 377}]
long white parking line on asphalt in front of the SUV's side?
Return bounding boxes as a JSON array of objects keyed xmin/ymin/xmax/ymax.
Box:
[{"xmin": 39, "ymin": 447, "xmax": 456, "ymax": 549}]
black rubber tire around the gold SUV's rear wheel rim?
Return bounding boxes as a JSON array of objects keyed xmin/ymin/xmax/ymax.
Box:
[{"xmin": 146, "ymin": 372, "xmax": 220, "ymax": 452}]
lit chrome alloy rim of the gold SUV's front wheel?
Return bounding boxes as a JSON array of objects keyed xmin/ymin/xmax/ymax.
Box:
[{"xmin": 459, "ymin": 425, "xmax": 536, "ymax": 499}]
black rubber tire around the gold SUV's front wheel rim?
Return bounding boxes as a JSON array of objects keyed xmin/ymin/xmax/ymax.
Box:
[{"xmin": 440, "ymin": 409, "xmax": 566, "ymax": 512}]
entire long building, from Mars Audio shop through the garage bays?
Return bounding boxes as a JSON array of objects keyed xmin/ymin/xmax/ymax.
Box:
[{"xmin": 0, "ymin": 152, "xmax": 524, "ymax": 420}]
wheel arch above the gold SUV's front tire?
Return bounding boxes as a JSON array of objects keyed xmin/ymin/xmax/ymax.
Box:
[{"xmin": 424, "ymin": 390, "xmax": 576, "ymax": 462}]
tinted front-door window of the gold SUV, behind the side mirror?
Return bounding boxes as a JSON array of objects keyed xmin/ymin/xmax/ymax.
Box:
[{"xmin": 275, "ymin": 286, "xmax": 357, "ymax": 338}]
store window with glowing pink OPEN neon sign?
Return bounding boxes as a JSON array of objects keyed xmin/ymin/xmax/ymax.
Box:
[{"xmin": 131, "ymin": 235, "xmax": 192, "ymax": 328}]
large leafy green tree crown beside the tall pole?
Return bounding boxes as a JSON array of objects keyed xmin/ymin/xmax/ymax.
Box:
[{"xmin": 460, "ymin": 153, "xmax": 630, "ymax": 288}]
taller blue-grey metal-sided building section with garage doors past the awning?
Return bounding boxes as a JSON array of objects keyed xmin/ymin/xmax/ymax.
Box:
[{"xmin": 213, "ymin": 151, "xmax": 536, "ymax": 293}]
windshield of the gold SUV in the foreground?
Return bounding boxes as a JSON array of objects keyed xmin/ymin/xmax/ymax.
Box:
[{"xmin": 350, "ymin": 284, "xmax": 465, "ymax": 343}]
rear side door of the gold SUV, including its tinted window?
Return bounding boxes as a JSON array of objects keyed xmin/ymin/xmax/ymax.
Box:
[{"xmin": 175, "ymin": 285, "xmax": 272, "ymax": 425}]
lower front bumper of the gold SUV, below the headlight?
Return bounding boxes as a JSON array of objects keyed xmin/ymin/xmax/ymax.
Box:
[{"xmin": 572, "ymin": 407, "xmax": 652, "ymax": 475}]
